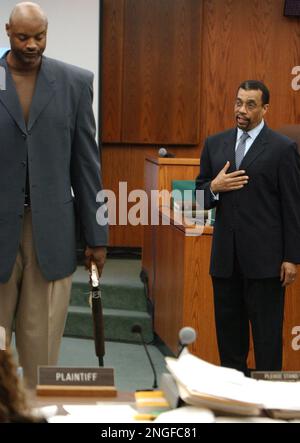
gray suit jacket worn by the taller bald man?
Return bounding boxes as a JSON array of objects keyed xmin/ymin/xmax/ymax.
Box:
[{"xmin": 0, "ymin": 57, "xmax": 108, "ymax": 283}]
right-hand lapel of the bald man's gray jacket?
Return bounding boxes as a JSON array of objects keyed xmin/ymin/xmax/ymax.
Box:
[{"xmin": 28, "ymin": 57, "xmax": 55, "ymax": 131}]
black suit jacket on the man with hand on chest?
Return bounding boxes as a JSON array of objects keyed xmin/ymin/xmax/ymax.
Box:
[{"xmin": 196, "ymin": 126, "xmax": 300, "ymax": 278}]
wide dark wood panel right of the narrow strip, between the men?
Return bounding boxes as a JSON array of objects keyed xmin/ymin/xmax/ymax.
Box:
[{"xmin": 122, "ymin": 0, "xmax": 201, "ymax": 144}]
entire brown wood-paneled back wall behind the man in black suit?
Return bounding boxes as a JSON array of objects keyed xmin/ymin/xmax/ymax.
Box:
[{"xmin": 102, "ymin": 0, "xmax": 300, "ymax": 246}]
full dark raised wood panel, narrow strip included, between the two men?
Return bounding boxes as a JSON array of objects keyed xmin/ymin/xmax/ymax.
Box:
[{"xmin": 103, "ymin": 0, "xmax": 201, "ymax": 144}]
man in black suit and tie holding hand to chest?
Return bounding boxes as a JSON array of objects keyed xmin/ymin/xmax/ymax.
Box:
[{"xmin": 196, "ymin": 81, "xmax": 300, "ymax": 374}]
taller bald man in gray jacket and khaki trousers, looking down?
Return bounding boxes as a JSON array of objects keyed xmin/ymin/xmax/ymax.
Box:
[{"xmin": 0, "ymin": 2, "xmax": 108, "ymax": 386}]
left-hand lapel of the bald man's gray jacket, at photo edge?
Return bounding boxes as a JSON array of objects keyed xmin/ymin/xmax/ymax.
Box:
[{"xmin": 0, "ymin": 58, "xmax": 27, "ymax": 133}]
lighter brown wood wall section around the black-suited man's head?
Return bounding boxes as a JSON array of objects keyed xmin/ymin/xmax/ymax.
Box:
[{"xmin": 200, "ymin": 0, "xmax": 300, "ymax": 140}]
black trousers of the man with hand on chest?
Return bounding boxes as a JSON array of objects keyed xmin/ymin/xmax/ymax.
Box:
[{"xmin": 212, "ymin": 264, "xmax": 285, "ymax": 375}]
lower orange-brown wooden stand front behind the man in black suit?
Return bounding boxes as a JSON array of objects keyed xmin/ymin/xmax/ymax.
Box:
[{"xmin": 153, "ymin": 208, "xmax": 300, "ymax": 371}]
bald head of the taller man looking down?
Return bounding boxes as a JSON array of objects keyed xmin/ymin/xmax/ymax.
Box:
[{"xmin": 6, "ymin": 2, "xmax": 48, "ymax": 70}]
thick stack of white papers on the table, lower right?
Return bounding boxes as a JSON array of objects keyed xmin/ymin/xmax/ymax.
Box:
[{"xmin": 166, "ymin": 353, "xmax": 300, "ymax": 419}]
